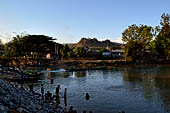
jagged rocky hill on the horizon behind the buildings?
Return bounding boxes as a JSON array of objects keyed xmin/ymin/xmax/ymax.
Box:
[{"xmin": 74, "ymin": 38, "xmax": 122, "ymax": 48}]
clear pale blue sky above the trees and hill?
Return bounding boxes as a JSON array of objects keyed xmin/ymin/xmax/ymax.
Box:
[{"xmin": 0, "ymin": 0, "xmax": 170, "ymax": 43}]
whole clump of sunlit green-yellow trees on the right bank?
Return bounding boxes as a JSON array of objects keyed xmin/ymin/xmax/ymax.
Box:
[{"xmin": 122, "ymin": 13, "xmax": 170, "ymax": 61}]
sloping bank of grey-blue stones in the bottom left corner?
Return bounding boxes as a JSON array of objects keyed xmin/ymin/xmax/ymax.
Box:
[{"xmin": 0, "ymin": 80, "xmax": 64, "ymax": 113}]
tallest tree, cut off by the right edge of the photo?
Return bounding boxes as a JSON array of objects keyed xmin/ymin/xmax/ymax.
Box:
[{"xmin": 156, "ymin": 13, "xmax": 170, "ymax": 60}]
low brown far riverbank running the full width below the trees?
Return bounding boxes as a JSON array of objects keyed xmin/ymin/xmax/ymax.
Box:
[{"xmin": 0, "ymin": 58, "xmax": 170, "ymax": 70}]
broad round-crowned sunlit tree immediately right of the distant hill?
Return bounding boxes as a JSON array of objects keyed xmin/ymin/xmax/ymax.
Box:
[{"xmin": 122, "ymin": 24, "xmax": 154, "ymax": 61}]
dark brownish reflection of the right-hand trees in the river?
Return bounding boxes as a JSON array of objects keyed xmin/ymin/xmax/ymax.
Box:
[{"xmin": 123, "ymin": 66, "xmax": 170, "ymax": 112}]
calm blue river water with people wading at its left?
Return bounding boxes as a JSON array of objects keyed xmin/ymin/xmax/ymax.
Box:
[{"xmin": 30, "ymin": 66, "xmax": 170, "ymax": 113}]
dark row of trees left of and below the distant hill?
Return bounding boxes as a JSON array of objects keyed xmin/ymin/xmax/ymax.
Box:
[{"xmin": 0, "ymin": 34, "xmax": 117, "ymax": 59}]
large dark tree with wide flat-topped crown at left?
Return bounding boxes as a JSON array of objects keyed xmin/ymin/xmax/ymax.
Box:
[{"xmin": 4, "ymin": 35, "xmax": 55, "ymax": 58}]
